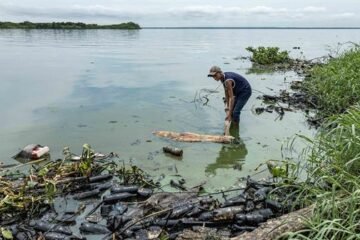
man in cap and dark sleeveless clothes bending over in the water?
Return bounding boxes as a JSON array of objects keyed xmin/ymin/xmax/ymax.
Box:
[{"xmin": 208, "ymin": 66, "xmax": 251, "ymax": 127}]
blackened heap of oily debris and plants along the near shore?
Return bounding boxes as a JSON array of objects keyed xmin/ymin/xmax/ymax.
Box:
[{"xmin": 0, "ymin": 145, "xmax": 295, "ymax": 239}]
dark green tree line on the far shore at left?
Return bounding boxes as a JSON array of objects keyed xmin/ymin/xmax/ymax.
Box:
[{"xmin": 0, "ymin": 21, "xmax": 141, "ymax": 29}]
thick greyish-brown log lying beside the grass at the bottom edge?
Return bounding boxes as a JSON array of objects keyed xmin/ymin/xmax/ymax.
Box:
[{"xmin": 231, "ymin": 205, "xmax": 314, "ymax": 240}]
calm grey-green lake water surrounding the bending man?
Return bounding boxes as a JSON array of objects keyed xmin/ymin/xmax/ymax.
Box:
[{"xmin": 0, "ymin": 29, "xmax": 360, "ymax": 191}]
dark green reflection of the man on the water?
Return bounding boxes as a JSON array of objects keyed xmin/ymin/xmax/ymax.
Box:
[{"xmin": 205, "ymin": 138, "xmax": 248, "ymax": 175}]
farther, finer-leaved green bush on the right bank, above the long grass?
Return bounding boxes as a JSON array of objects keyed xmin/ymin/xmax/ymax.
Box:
[{"xmin": 304, "ymin": 46, "xmax": 360, "ymax": 117}]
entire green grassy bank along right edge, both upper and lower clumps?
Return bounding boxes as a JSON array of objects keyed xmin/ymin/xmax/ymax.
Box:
[{"xmin": 258, "ymin": 45, "xmax": 360, "ymax": 240}]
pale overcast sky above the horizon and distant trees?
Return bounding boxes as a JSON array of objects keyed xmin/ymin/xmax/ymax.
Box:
[{"xmin": 0, "ymin": 0, "xmax": 360, "ymax": 27}]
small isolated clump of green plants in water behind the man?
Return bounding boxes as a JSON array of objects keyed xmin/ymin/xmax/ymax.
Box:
[{"xmin": 246, "ymin": 46, "xmax": 291, "ymax": 65}]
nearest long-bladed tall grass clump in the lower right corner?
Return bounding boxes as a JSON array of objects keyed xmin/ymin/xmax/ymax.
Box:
[{"xmin": 286, "ymin": 105, "xmax": 360, "ymax": 240}]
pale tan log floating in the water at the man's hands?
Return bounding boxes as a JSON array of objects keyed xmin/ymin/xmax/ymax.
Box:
[{"xmin": 153, "ymin": 131, "xmax": 234, "ymax": 143}]
